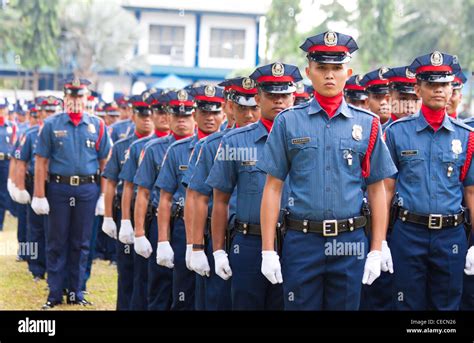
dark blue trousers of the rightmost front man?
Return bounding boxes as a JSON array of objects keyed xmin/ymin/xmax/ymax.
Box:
[{"xmin": 390, "ymin": 220, "xmax": 467, "ymax": 311}]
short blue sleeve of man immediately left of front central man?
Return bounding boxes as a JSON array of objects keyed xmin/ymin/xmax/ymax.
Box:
[{"xmin": 206, "ymin": 137, "xmax": 238, "ymax": 194}]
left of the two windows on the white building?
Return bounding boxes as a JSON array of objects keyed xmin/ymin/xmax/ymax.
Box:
[{"xmin": 148, "ymin": 25, "xmax": 184, "ymax": 57}]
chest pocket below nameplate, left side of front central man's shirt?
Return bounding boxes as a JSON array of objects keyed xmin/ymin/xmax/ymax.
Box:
[{"xmin": 288, "ymin": 137, "xmax": 319, "ymax": 171}]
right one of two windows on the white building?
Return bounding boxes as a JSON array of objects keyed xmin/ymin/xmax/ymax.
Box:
[{"xmin": 209, "ymin": 29, "xmax": 245, "ymax": 60}]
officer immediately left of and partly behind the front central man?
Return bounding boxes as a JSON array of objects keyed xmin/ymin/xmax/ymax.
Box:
[{"xmin": 207, "ymin": 62, "xmax": 302, "ymax": 310}]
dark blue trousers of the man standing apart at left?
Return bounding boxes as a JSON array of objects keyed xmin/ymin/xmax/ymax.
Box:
[{"xmin": 47, "ymin": 182, "xmax": 99, "ymax": 302}]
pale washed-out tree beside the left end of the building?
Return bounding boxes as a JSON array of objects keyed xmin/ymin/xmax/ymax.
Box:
[{"xmin": 61, "ymin": 0, "xmax": 146, "ymax": 88}]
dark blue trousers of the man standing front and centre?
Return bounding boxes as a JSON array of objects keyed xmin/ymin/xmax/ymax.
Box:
[{"xmin": 281, "ymin": 229, "xmax": 368, "ymax": 311}]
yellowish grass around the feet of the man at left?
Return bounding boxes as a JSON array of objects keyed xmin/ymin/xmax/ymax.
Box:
[{"xmin": 0, "ymin": 214, "xmax": 117, "ymax": 310}]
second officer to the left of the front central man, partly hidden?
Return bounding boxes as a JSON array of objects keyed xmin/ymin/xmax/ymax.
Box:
[{"xmin": 185, "ymin": 77, "xmax": 260, "ymax": 311}]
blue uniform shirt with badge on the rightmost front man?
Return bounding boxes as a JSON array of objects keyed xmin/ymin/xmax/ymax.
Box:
[{"xmin": 385, "ymin": 112, "xmax": 474, "ymax": 215}]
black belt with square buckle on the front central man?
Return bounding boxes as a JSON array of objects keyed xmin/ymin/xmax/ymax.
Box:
[{"xmin": 286, "ymin": 216, "xmax": 367, "ymax": 237}]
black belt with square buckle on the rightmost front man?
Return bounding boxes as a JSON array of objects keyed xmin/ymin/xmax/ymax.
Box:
[{"xmin": 398, "ymin": 207, "xmax": 466, "ymax": 230}]
